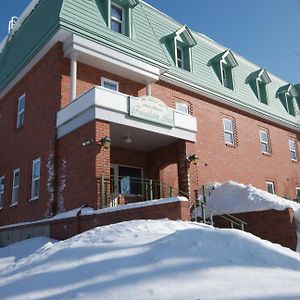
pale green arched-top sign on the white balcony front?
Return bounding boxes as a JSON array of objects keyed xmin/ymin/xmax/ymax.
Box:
[{"xmin": 129, "ymin": 96, "xmax": 174, "ymax": 127}]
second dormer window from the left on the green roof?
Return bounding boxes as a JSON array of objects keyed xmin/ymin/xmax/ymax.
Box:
[{"xmin": 166, "ymin": 26, "xmax": 196, "ymax": 71}]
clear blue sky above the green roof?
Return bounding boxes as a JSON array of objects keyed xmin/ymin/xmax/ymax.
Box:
[{"xmin": 0, "ymin": 0, "xmax": 300, "ymax": 83}]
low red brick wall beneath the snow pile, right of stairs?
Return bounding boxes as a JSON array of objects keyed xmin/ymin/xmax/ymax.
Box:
[{"xmin": 214, "ymin": 208, "xmax": 297, "ymax": 251}]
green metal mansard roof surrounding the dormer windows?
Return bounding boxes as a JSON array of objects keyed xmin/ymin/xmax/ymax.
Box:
[{"xmin": 0, "ymin": 0, "xmax": 300, "ymax": 128}]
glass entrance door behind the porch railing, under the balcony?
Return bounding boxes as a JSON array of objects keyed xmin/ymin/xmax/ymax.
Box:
[{"xmin": 110, "ymin": 164, "xmax": 143, "ymax": 203}]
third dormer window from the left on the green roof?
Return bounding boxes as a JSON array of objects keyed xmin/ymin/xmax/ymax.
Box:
[{"xmin": 209, "ymin": 50, "xmax": 238, "ymax": 90}]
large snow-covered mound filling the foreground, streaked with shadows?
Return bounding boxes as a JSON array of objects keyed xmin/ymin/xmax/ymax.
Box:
[{"xmin": 0, "ymin": 220, "xmax": 300, "ymax": 300}]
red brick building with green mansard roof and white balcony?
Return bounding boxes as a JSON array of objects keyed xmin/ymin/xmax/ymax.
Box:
[{"xmin": 0, "ymin": 0, "xmax": 300, "ymax": 232}]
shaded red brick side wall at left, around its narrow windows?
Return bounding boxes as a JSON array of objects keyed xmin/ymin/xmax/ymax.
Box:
[{"xmin": 0, "ymin": 44, "xmax": 63, "ymax": 225}]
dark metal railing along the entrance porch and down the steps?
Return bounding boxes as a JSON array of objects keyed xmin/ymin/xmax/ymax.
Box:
[{"xmin": 97, "ymin": 175, "xmax": 247, "ymax": 230}]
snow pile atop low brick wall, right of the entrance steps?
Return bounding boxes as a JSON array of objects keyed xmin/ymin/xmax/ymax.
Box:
[{"xmin": 206, "ymin": 181, "xmax": 300, "ymax": 219}]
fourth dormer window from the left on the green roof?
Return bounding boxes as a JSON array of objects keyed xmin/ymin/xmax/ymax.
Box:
[{"xmin": 246, "ymin": 69, "xmax": 271, "ymax": 104}]
